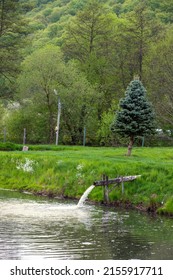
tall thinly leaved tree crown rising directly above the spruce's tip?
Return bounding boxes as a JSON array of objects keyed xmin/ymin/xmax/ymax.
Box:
[{"xmin": 119, "ymin": 0, "xmax": 162, "ymax": 80}]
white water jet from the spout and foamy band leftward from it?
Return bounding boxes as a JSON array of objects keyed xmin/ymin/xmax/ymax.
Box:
[{"xmin": 0, "ymin": 185, "xmax": 94, "ymax": 224}]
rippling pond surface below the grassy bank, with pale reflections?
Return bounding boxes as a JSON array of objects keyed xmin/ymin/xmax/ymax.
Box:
[{"xmin": 0, "ymin": 190, "xmax": 173, "ymax": 260}]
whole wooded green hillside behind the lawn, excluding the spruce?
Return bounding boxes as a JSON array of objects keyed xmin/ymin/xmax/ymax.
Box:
[{"xmin": 0, "ymin": 0, "xmax": 173, "ymax": 145}]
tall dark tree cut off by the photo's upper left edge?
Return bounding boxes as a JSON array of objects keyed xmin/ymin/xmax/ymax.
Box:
[{"xmin": 0, "ymin": 0, "xmax": 26, "ymax": 98}]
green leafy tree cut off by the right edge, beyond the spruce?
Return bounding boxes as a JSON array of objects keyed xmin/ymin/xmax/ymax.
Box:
[{"xmin": 147, "ymin": 29, "xmax": 173, "ymax": 130}]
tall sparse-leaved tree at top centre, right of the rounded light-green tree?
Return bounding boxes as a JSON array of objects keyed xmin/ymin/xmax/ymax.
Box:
[{"xmin": 63, "ymin": 0, "xmax": 118, "ymax": 112}]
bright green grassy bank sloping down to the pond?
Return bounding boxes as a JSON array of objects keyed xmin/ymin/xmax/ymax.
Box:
[{"xmin": 0, "ymin": 146, "xmax": 173, "ymax": 214}]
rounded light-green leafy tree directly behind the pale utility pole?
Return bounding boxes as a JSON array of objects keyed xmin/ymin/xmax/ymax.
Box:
[{"xmin": 19, "ymin": 45, "xmax": 99, "ymax": 144}]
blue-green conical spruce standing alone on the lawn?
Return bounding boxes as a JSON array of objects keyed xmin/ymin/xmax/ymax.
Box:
[{"xmin": 111, "ymin": 78, "xmax": 155, "ymax": 156}]
